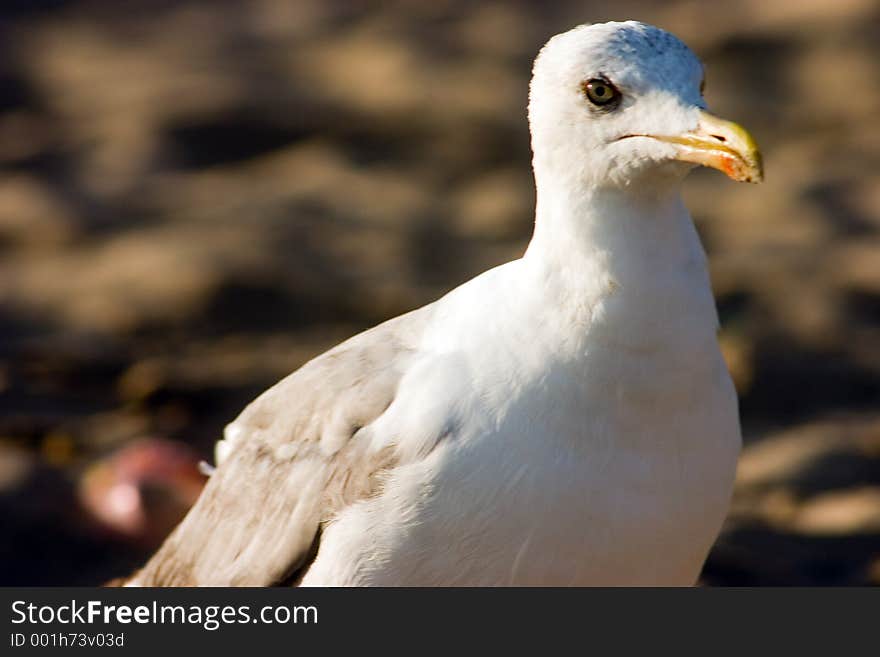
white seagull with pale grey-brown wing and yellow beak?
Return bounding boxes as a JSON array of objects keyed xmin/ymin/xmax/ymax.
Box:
[{"xmin": 127, "ymin": 21, "xmax": 763, "ymax": 586}]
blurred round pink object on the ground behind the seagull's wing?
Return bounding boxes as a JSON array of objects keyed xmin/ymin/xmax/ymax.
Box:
[{"xmin": 79, "ymin": 438, "xmax": 206, "ymax": 542}]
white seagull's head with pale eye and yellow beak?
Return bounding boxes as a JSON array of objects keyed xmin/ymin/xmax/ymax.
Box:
[{"xmin": 529, "ymin": 21, "xmax": 763, "ymax": 187}]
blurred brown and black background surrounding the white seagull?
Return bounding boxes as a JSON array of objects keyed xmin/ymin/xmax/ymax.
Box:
[{"xmin": 0, "ymin": 0, "xmax": 880, "ymax": 585}]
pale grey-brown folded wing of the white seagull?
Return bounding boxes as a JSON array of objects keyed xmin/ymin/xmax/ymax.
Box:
[{"xmin": 131, "ymin": 306, "xmax": 430, "ymax": 586}]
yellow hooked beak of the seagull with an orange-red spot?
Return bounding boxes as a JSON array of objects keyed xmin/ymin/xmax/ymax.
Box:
[{"xmin": 646, "ymin": 111, "xmax": 764, "ymax": 183}]
